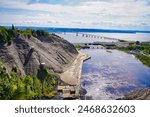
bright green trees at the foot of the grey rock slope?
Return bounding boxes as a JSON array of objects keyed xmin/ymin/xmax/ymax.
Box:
[{"xmin": 0, "ymin": 62, "xmax": 57, "ymax": 100}]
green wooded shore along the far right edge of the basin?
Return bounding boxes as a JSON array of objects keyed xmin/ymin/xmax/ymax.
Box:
[{"xmin": 116, "ymin": 41, "xmax": 150, "ymax": 67}]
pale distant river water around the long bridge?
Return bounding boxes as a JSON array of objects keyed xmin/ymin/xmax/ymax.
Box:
[{"xmin": 56, "ymin": 33, "xmax": 150, "ymax": 43}]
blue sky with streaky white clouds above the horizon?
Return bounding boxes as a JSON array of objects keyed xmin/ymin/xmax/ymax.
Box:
[{"xmin": 0, "ymin": 0, "xmax": 150, "ymax": 30}]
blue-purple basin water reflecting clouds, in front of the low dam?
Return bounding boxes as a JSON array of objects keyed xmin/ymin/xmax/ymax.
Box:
[{"xmin": 81, "ymin": 49, "xmax": 150, "ymax": 100}]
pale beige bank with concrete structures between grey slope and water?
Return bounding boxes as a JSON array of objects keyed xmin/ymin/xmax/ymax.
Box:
[{"xmin": 58, "ymin": 51, "xmax": 90, "ymax": 99}]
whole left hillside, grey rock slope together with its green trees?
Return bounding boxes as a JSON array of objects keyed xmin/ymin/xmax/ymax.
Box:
[{"xmin": 0, "ymin": 25, "xmax": 77, "ymax": 100}]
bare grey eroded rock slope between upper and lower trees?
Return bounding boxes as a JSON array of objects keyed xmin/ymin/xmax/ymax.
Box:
[{"xmin": 0, "ymin": 35, "xmax": 78, "ymax": 75}]
